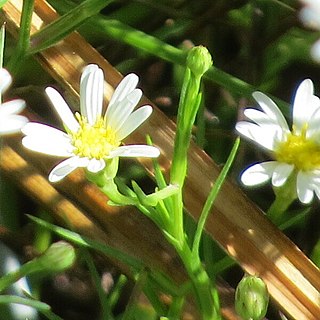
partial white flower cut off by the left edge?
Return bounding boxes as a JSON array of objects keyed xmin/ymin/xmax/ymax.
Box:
[{"xmin": 0, "ymin": 69, "xmax": 28, "ymax": 135}]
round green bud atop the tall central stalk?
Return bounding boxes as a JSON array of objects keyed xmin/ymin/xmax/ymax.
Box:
[{"xmin": 187, "ymin": 46, "xmax": 212, "ymax": 77}]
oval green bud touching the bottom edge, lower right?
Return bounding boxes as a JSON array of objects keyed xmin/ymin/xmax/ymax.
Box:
[{"xmin": 235, "ymin": 276, "xmax": 269, "ymax": 320}]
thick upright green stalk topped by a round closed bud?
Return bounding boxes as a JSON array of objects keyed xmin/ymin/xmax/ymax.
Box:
[{"xmin": 168, "ymin": 47, "xmax": 221, "ymax": 320}]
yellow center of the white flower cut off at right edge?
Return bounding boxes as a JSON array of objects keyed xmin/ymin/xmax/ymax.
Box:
[{"xmin": 275, "ymin": 124, "xmax": 320, "ymax": 171}]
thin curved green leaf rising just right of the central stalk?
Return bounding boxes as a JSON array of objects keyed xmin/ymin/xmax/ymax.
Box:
[{"xmin": 192, "ymin": 138, "xmax": 240, "ymax": 256}]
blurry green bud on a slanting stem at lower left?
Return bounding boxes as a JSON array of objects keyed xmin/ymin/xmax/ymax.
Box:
[{"xmin": 33, "ymin": 241, "xmax": 76, "ymax": 273}]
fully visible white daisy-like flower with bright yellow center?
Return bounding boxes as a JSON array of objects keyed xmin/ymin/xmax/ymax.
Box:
[{"xmin": 22, "ymin": 64, "xmax": 160, "ymax": 182}]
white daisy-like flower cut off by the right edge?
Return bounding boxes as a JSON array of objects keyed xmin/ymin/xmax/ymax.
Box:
[{"xmin": 236, "ymin": 79, "xmax": 320, "ymax": 204}]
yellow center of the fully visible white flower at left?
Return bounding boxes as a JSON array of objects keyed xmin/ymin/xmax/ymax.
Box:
[{"xmin": 69, "ymin": 113, "xmax": 120, "ymax": 159}]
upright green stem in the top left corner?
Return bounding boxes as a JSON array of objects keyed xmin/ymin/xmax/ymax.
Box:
[{"xmin": 8, "ymin": 0, "xmax": 34, "ymax": 75}]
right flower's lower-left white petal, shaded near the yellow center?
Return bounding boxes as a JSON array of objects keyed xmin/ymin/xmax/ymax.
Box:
[{"xmin": 240, "ymin": 161, "xmax": 279, "ymax": 186}]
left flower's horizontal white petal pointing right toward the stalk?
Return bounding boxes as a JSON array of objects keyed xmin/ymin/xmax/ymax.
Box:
[{"xmin": 108, "ymin": 145, "xmax": 160, "ymax": 158}]
